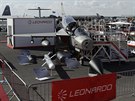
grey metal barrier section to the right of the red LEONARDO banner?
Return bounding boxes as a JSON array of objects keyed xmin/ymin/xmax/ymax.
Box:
[{"xmin": 116, "ymin": 69, "xmax": 135, "ymax": 96}]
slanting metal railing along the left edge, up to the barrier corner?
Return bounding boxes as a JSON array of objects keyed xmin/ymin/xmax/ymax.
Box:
[{"xmin": 2, "ymin": 60, "xmax": 29, "ymax": 101}]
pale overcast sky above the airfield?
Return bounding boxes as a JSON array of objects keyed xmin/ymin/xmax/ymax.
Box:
[{"xmin": 0, "ymin": 0, "xmax": 135, "ymax": 16}]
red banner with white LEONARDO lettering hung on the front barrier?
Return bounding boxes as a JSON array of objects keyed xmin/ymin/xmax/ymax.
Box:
[{"xmin": 52, "ymin": 73, "xmax": 116, "ymax": 101}]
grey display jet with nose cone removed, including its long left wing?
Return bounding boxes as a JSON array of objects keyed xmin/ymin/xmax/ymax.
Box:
[{"xmin": 10, "ymin": 16, "xmax": 93, "ymax": 55}]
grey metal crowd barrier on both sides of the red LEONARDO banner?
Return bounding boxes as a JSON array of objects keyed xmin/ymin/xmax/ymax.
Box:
[{"xmin": 3, "ymin": 57, "xmax": 135, "ymax": 101}]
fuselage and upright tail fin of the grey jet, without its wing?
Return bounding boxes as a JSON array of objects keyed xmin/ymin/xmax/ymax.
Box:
[{"xmin": 58, "ymin": 3, "xmax": 93, "ymax": 52}]
